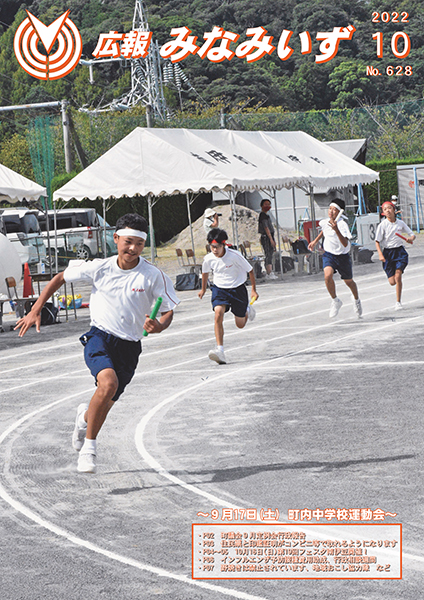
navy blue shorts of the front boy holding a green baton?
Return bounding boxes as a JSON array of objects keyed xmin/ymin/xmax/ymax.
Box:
[{"xmin": 80, "ymin": 326, "xmax": 141, "ymax": 402}]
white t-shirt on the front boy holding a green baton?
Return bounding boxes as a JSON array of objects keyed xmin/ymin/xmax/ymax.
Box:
[{"xmin": 64, "ymin": 256, "xmax": 180, "ymax": 342}]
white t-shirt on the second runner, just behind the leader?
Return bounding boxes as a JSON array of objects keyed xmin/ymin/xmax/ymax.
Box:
[{"xmin": 202, "ymin": 248, "xmax": 252, "ymax": 290}]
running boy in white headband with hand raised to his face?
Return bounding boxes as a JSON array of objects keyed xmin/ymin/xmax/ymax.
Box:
[{"xmin": 308, "ymin": 200, "xmax": 362, "ymax": 318}]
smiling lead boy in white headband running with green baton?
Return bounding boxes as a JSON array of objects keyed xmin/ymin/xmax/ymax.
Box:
[{"xmin": 16, "ymin": 214, "xmax": 179, "ymax": 473}]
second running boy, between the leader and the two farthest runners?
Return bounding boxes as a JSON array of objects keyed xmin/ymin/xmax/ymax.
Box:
[{"xmin": 199, "ymin": 228, "xmax": 259, "ymax": 365}]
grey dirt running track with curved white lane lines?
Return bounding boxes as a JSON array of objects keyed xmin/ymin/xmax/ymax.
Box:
[{"xmin": 0, "ymin": 251, "xmax": 424, "ymax": 600}]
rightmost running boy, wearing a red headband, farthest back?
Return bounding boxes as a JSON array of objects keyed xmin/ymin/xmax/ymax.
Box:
[{"xmin": 375, "ymin": 201, "xmax": 415, "ymax": 310}]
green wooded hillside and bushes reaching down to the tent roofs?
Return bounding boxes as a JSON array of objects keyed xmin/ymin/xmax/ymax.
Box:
[{"xmin": 0, "ymin": 0, "xmax": 424, "ymax": 199}]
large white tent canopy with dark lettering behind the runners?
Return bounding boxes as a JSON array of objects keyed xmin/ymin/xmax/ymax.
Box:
[{"xmin": 53, "ymin": 127, "xmax": 378, "ymax": 201}]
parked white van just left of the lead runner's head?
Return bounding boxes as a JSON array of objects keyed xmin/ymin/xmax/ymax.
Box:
[{"xmin": 38, "ymin": 208, "xmax": 115, "ymax": 263}]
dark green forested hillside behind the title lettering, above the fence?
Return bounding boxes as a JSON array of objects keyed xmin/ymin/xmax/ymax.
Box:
[{"xmin": 0, "ymin": 0, "xmax": 424, "ymax": 120}]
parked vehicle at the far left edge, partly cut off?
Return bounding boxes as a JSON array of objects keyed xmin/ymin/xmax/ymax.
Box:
[{"xmin": 0, "ymin": 208, "xmax": 46, "ymax": 265}]
